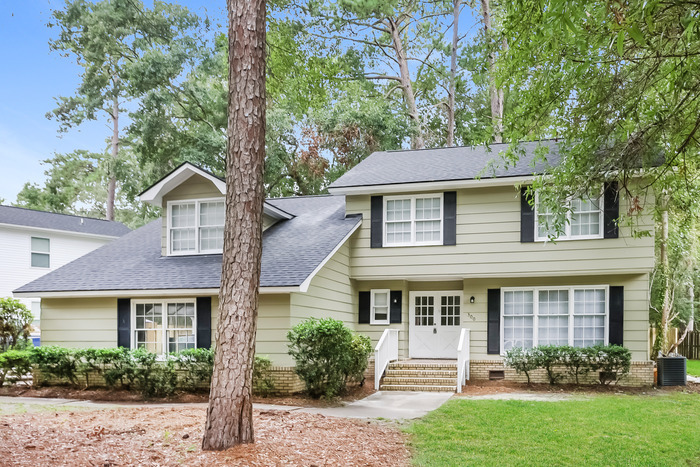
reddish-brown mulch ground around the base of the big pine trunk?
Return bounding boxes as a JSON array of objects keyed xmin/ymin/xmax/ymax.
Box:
[{"xmin": 0, "ymin": 407, "xmax": 410, "ymax": 467}]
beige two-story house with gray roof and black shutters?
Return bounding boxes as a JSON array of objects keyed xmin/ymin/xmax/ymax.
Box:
[{"xmin": 16, "ymin": 141, "xmax": 654, "ymax": 390}]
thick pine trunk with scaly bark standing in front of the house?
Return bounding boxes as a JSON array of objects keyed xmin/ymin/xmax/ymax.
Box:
[{"xmin": 202, "ymin": 0, "xmax": 265, "ymax": 450}]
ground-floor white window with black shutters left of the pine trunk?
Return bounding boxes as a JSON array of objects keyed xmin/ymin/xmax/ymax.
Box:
[{"xmin": 131, "ymin": 299, "xmax": 197, "ymax": 355}]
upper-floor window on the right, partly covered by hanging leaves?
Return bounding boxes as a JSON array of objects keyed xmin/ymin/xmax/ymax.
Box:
[{"xmin": 535, "ymin": 193, "xmax": 603, "ymax": 241}]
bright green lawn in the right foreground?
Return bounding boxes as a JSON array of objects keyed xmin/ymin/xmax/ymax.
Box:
[{"xmin": 407, "ymin": 393, "xmax": 700, "ymax": 466}]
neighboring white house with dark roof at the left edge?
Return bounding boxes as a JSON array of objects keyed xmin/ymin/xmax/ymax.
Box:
[{"xmin": 0, "ymin": 206, "xmax": 130, "ymax": 328}]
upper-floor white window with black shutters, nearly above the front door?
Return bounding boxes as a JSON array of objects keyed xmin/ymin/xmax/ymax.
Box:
[{"xmin": 384, "ymin": 193, "xmax": 443, "ymax": 246}]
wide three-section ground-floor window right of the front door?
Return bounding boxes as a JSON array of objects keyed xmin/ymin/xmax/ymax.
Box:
[{"xmin": 501, "ymin": 285, "xmax": 609, "ymax": 352}]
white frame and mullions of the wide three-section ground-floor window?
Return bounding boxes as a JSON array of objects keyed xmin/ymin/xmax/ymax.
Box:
[{"xmin": 499, "ymin": 285, "xmax": 610, "ymax": 356}]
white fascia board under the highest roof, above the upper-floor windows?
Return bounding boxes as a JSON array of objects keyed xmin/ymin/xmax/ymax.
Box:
[{"xmin": 328, "ymin": 175, "xmax": 535, "ymax": 195}]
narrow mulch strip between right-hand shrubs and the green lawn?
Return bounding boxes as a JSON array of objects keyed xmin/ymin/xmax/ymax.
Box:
[{"xmin": 460, "ymin": 380, "xmax": 700, "ymax": 396}]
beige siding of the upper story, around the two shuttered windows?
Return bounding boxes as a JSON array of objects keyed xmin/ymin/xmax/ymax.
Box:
[{"xmin": 346, "ymin": 187, "xmax": 654, "ymax": 280}]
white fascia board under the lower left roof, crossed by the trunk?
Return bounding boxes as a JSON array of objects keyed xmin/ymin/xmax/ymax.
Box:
[{"xmin": 12, "ymin": 286, "xmax": 300, "ymax": 298}]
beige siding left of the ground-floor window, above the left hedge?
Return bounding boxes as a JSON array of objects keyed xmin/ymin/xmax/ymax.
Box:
[{"xmin": 41, "ymin": 298, "xmax": 117, "ymax": 348}]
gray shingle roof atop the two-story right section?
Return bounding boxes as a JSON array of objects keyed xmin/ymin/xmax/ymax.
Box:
[{"xmin": 330, "ymin": 140, "xmax": 559, "ymax": 189}]
